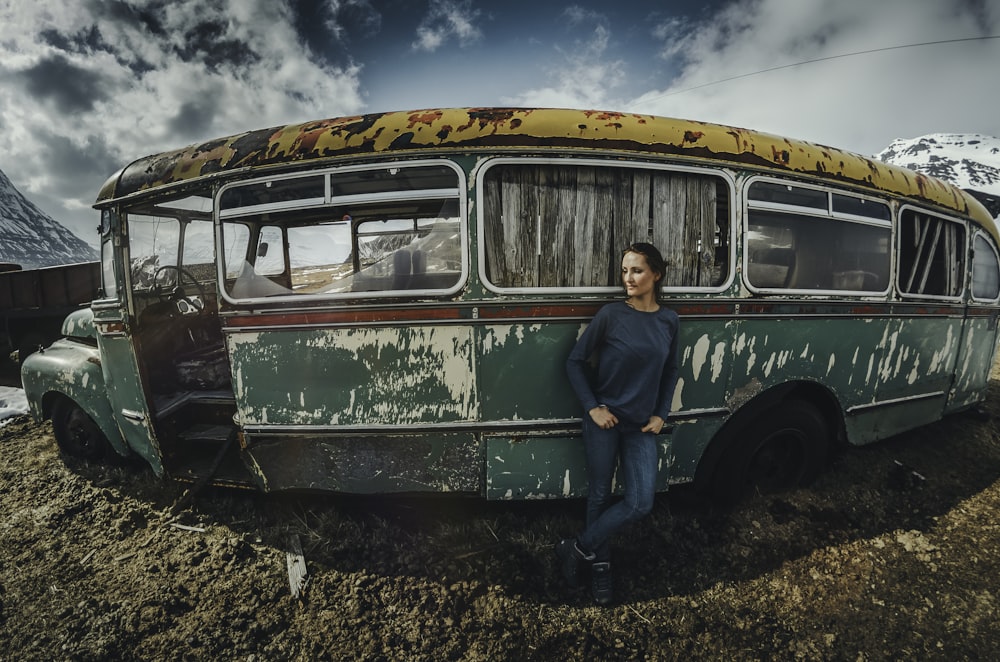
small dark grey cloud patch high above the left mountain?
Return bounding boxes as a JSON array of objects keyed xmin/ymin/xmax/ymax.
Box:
[{"xmin": 19, "ymin": 54, "xmax": 108, "ymax": 114}]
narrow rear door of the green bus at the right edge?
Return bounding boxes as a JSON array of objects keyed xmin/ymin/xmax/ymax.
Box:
[{"xmin": 947, "ymin": 232, "xmax": 1000, "ymax": 411}]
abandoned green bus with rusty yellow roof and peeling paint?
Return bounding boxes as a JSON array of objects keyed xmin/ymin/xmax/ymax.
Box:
[{"xmin": 23, "ymin": 109, "xmax": 1000, "ymax": 499}]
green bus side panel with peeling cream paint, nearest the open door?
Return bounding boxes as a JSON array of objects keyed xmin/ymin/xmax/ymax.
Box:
[{"xmin": 227, "ymin": 325, "xmax": 479, "ymax": 429}]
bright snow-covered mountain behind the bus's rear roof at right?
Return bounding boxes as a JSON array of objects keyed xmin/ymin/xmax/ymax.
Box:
[{"xmin": 875, "ymin": 133, "xmax": 1000, "ymax": 216}]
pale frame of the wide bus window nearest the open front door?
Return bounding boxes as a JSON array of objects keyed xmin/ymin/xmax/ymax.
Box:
[{"xmin": 212, "ymin": 158, "xmax": 470, "ymax": 308}]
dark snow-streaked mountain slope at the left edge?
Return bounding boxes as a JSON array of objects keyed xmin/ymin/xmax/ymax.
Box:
[{"xmin": 0, "ymin": 171, "xmax": 98, "ymax": 269}]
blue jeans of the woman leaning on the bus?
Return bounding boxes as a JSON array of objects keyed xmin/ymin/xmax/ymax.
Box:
[{"xmin": 577, "ymin": 416, "xmax": 657, "ymax": 561}]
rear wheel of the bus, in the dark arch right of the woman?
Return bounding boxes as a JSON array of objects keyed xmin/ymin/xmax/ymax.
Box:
[{"xmin": 714, "ymin": 400, "xmax": 830, "ymax": 502}]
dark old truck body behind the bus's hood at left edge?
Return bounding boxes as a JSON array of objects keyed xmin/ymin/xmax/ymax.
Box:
[{"xmin": 0, "ymin": 262, "xmax": 101, "ymax": 360}]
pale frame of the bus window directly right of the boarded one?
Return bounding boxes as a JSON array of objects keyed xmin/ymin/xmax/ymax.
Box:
[{"xmin": 740, "ymin": 175, "xmax": 896, "ymax": 298}]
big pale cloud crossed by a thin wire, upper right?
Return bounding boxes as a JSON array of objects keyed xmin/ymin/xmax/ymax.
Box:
[{"xmin": 626, "ymin": 0, "xmax": 1000, "ymax": 154}]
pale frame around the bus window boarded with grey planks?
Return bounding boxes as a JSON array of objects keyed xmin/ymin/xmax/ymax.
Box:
[{"xmin": 475, "ymin": 156, "xmax": 737, "ymax": 296}]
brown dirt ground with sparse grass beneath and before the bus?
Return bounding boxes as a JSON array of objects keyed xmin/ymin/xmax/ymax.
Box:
[{"xmin": 0, "ymin": 364, "xmax": 1000, "ymax": 662}]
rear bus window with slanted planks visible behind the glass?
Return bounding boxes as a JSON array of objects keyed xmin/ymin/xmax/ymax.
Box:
[{"xmin": 899, "ymin": 209, "xmax": 966, "ymax": 297}]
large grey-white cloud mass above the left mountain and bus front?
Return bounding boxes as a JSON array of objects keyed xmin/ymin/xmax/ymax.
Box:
[{"xmin": 0, "ymin": 0, "xmax": 368, "ymax": 241}]
